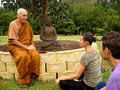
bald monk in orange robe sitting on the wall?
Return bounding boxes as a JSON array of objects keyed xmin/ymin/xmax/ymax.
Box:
[{"xmin": 8, "ymin": 8, "xmax": 40, "ymax": 87}]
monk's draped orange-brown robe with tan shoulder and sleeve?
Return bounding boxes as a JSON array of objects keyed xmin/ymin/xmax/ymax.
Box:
[{"xmin": 8, "ymin": 20, "xmax": 40, "ymax": 85}]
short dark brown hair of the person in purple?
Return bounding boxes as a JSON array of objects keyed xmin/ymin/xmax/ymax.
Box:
[{"xmin": 102, "ymin": 31, "xmax": 120, "ymax": 59}]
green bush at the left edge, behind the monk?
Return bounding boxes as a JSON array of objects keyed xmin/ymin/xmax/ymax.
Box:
[{"xmin": 0, "ymin": 13, "xmax": 16, "ymax": 35}]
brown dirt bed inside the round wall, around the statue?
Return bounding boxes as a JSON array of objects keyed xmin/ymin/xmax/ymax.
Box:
[{"xmin": 0, "ymin": 40, "xmax": 81, "ymax": 52}]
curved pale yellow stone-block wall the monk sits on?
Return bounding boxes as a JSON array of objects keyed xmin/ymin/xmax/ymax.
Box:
[{"xmin": 0, "ymin": 42, "xmax": 97, "ymax": 80}]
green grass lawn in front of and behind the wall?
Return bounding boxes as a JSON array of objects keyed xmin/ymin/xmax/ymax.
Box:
[{"xmin": 0, "ymin": 35, "xmax": 111, "ymax": 90}]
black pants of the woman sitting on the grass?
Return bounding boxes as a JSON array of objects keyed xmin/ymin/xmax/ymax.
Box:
[{"xmin": 59, "ymin": 80, "xmax": 94, "ymax": 90}]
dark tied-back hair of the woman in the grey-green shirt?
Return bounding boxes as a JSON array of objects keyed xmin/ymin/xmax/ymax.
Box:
[{"xmin": 82, "ymin": 32, "xmax": 96, "ymax": 45}]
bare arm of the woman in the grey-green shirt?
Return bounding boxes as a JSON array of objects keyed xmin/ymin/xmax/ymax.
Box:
[{"xmin": 56, "ymin": 64, "xmax": 85, "ymax": 85}]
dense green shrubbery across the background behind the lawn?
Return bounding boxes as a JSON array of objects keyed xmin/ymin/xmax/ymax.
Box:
[{"xmin": 0, "ymin": 0, "xmax": 120, "ymax": 35}]
